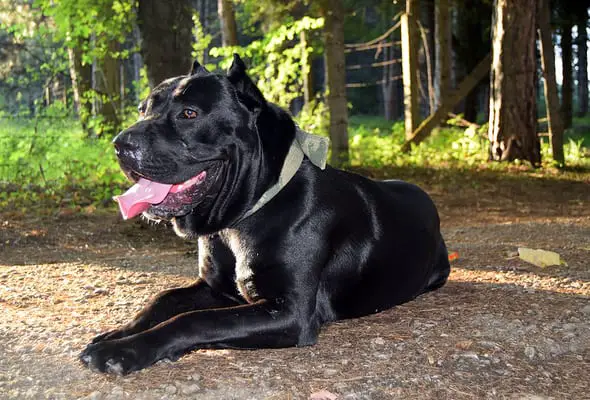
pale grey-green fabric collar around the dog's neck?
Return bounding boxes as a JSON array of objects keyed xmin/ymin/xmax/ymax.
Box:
[{"xmin": 240, "ymin": 127, "xmax": 330, "ymax": 220}]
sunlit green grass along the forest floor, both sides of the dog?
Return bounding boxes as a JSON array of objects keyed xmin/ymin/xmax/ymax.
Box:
[{"xmin": 0, "ymin": 112, "xmax": 590, "ymax": 212}]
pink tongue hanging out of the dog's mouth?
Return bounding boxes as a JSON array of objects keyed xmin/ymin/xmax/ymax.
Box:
[{"xmin": 114, "ymin": 178, "xmax": 172, "ymax": 219}]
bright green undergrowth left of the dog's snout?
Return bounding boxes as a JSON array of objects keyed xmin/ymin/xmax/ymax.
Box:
[{"xmin": 0, "ymin": 112, "xmax": 125, "ymax": 206}]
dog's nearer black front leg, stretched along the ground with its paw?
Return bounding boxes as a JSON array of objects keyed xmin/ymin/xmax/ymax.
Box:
[{"xmin": 80, "ymin": 301, "xmax": 319, "ymax": 374}]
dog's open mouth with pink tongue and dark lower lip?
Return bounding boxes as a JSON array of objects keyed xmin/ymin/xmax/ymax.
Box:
[{"xmin": 114, "ymin": 171, "xmax": 209, "ymax": 219}]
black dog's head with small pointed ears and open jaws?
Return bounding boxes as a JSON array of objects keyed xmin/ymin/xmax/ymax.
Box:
[{"xmin": 113, "ymin": 55, "xmax": 294, "ymax": 233}]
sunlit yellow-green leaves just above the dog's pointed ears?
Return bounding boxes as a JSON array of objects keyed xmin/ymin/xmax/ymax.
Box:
[{"xmin": 210, "ymin": 17, "xmax": 324, "ymax": 108}]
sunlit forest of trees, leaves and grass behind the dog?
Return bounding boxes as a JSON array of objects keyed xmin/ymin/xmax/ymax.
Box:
[{"xmin": 0, "ymin": 0, "xmax": 590, "ymax": 211}]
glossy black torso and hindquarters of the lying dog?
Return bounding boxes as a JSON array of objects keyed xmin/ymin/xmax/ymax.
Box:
[{"xmin": 285, "ymin": 162, "xmax": 450, "ymax": 320}]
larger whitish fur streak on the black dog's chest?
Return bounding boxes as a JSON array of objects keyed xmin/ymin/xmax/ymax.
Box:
[{"xmin": 219, "ymin": 229, "xmax": 259, "ymax": 303}]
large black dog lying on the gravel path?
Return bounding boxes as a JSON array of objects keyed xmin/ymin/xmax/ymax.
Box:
[{"xmin": 80, "ymin": 56, "xmax": 450, "ymax": 374}]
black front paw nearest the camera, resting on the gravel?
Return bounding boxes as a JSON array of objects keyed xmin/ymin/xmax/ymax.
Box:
[{"xmin": 80, "ymin": 339, "xmax": 157, "ymax": 375}]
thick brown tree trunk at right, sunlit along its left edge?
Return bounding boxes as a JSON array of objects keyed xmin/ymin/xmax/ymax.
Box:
[{"xmin": 488, "ymin": 0, "xmax": 541, "ymax": 167}]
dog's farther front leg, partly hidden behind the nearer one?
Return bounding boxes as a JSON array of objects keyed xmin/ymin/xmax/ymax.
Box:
[{"xmin": 92, "ymin": 279, "xmax": 239, "ymax": 343}]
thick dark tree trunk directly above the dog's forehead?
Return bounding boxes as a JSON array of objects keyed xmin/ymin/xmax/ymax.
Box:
[{"xmin": 137, "ymin": 0, "xmax": 194, "ymax": 88}]
